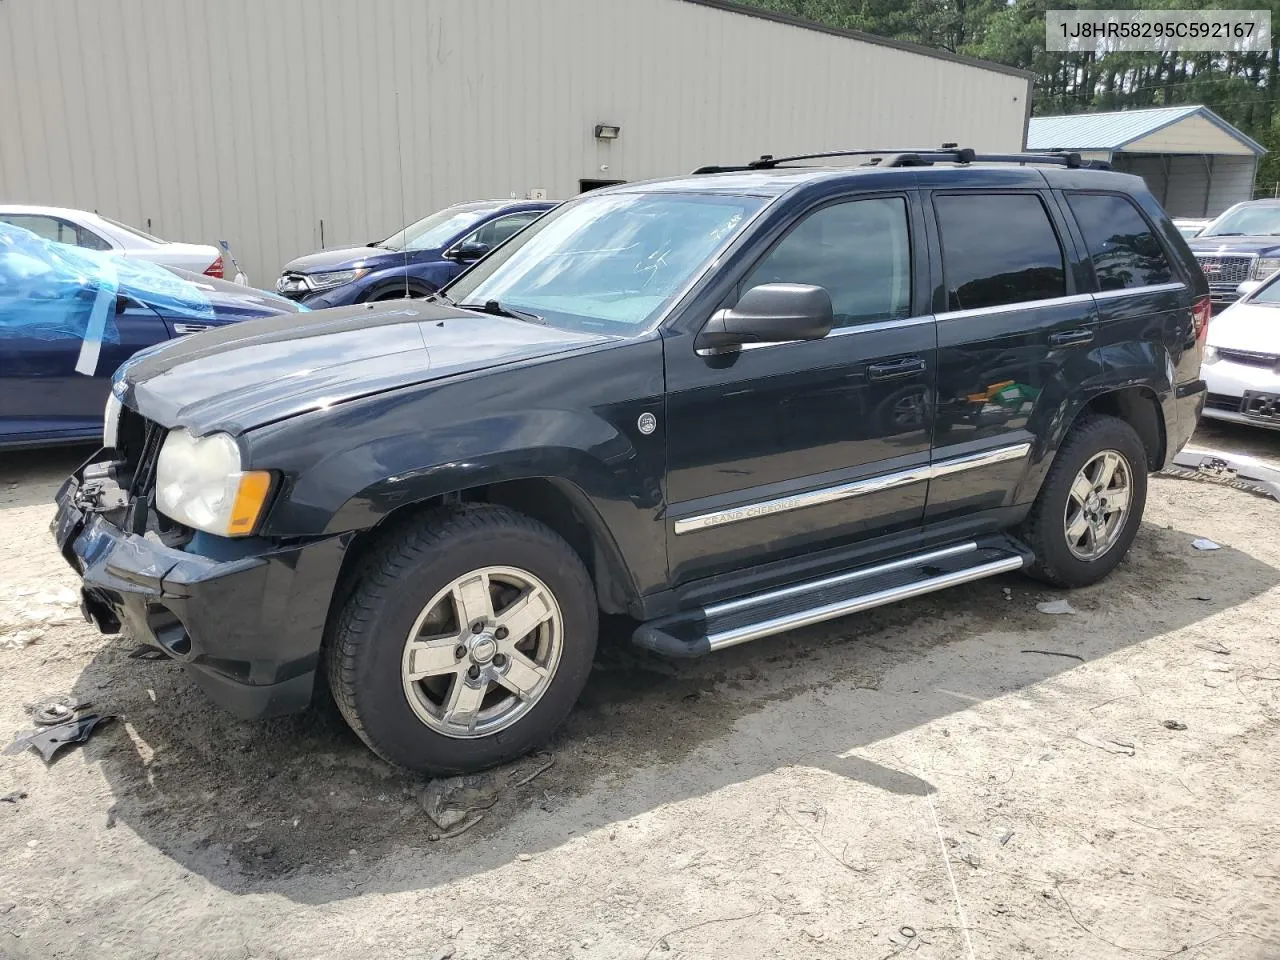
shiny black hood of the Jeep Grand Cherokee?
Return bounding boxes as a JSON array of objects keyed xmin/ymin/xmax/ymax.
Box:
[{"xmin": 116, "ymin": 300, "xmax": 608, "ymax": 435}]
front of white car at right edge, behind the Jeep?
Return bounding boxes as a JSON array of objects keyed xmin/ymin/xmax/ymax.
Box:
[{"xmin": 1201, "ymin": 274, "xmax": 1280, "ymax": 430}]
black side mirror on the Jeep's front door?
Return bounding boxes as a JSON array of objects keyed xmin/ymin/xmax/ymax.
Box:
[{"xmin": 694, "ymin": 283, "xmax": 835, "ymax": 349}]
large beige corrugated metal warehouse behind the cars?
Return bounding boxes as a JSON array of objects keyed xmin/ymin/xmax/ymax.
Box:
[{"xmin": 0, "ymin": 0, "xmax": 1030, "ymax": 285}]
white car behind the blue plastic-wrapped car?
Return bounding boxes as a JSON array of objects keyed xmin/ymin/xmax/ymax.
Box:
[{"xmin": 0, "ymin": 204, "xmax": 223, "ymax": 278}]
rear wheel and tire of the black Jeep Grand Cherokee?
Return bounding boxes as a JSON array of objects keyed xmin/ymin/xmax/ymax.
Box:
[{"xmin": 1021, "ymin": 416, "xmax": 1147, "ymax": 586}]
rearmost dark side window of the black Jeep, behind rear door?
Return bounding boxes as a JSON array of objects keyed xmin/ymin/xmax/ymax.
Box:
[{"xmin": 1066, "ymin": 193, "xmax": 1174, "ymax": 291}]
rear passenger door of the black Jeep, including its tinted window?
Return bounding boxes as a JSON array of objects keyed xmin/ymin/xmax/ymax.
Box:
[{"xmin": 925, "ymin": 189, "xmax": 1097, "ymax": 522}]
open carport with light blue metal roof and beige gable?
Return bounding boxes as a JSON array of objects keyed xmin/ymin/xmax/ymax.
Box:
[{"xmin": 1027, "ymin": 105, "xmax": 1267, "ymax": 218}]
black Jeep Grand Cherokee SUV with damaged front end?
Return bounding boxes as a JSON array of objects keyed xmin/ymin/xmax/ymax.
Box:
[{"xmin": 54, "ymin": 150, "xmax": 1210, "ymax": 772}]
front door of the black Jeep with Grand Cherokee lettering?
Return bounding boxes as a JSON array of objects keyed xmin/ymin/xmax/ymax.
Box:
[{"xmin": 666, "ymin": 193, "xmax": 936, "ymax": 584}]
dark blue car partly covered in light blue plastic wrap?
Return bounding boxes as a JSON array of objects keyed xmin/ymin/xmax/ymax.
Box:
[{"xmin": 0, "ymin": 223, "xmax": 306, "ymax": 448}]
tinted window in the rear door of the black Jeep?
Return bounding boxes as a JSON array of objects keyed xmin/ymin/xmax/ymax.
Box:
[{"xmin": 933, "ymin": 193, "xmax": 1066, "ymax": 310}]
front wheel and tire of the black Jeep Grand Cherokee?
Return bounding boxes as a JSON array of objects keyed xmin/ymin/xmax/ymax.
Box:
[{"xmin": 325, "ymin": 504, "xmax": 598, "ymax": 774}]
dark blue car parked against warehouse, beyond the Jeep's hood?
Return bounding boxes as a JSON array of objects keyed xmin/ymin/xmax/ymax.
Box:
[{"xmin": 275, "ymin": 200, "xmax": 556, "ymax": 310}]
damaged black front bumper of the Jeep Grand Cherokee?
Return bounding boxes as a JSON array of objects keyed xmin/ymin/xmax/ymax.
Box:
[{"xmin": 50, "ymin": 467, "xmax": 346, "ymax": 719}]
